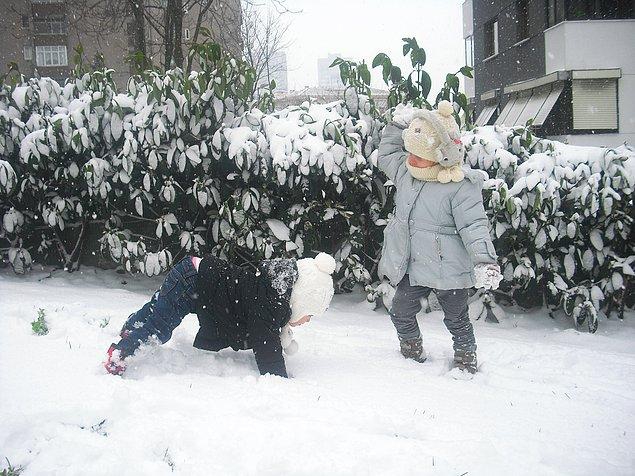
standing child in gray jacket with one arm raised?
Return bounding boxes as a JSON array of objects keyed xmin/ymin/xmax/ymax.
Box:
[{"xmin": 378, "ymin": 101, "xmax": 502, "ymax": 373}]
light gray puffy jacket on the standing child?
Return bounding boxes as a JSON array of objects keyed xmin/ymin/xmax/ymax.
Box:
[{"xmin": 377, "ymin": 123, "xmax": 497, "ymax": 289}]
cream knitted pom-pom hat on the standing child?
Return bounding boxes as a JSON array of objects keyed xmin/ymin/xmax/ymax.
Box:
[{"xmin": 403, "ymin": 101, "xmax": 465, "ymax": 183}]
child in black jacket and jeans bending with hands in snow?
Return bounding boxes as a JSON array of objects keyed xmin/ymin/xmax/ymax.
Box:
[{"xmin": 104, "ymin": 253, "xmax": 335, "ymax": 377}]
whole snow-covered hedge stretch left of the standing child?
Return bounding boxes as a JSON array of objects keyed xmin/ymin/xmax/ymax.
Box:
[{"xmin": 0, "ymin": 44, "xmax": 387, "ymax": 288}]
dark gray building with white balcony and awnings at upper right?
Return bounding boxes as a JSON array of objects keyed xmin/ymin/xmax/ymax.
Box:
[{"xmin": 463, "ymin": 0, "xmax": 635, "ymax": 146}]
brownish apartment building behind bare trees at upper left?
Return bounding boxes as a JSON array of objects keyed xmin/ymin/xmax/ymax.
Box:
[{"xmin": 0, "ymin": 0, "xmax": 241, "ymax": 86}]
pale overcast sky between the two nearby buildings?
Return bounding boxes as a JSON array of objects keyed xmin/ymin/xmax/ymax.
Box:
[{"xmin": 287, "ymin": 0, "xmax": 465, "ymax": 91}]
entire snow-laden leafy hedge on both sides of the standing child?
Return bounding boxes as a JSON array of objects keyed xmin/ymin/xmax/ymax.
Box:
[{"xmin": 0, "ymin": 40, "xmax": 635, "ymax": 330}]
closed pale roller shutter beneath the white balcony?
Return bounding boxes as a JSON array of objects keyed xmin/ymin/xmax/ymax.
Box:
[{"xmin": 573, "ymin": 79, "xmax": 617, "ymax": 130}]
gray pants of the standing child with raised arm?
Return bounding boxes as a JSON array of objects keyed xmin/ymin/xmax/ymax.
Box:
[{"xmin": 390, "ymin": 275, "xmax": 476, "ymax": 352}]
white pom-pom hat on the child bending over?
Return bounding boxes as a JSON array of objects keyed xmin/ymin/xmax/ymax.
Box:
[{"xmin": 289, "ymin": 253, "xmax": 335, "ymax": 322}]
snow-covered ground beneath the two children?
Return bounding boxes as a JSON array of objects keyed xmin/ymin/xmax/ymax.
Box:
[{"xmin": 0, "ymin": 268, "xmax": 635, "ymax": 476}]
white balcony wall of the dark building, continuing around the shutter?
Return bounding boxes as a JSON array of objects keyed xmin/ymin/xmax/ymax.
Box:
[{"xmin": 545, "ymin": 20, "xmax": 635, "ymax": 146}]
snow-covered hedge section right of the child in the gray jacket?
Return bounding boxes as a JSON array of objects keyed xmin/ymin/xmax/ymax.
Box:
[{"xmin": 462, "ymin": 127, "xmax": 635, "ymax": 331}]
